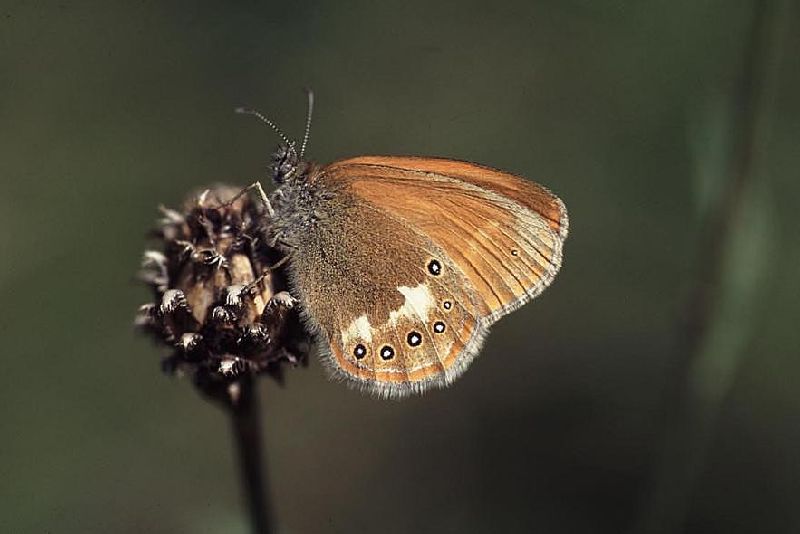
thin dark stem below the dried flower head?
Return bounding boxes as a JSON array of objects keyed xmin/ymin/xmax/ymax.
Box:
[{"xmin": 230, "ymin": 375, "xmax": 274, "ymax": 534}]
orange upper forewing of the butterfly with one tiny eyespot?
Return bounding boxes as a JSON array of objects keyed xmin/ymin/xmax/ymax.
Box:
[{"xmin": 327, "ymin": 156, "xmax": 568, "ymax": 324}]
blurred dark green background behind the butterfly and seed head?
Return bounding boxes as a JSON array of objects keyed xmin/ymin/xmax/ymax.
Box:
[{"xmin": 0, "ymin": 0, "xmax": 800, "ymax": 533}]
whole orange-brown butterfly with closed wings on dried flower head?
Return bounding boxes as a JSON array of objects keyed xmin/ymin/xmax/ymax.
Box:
[{"xmin": 237, "ymin": 91, "xmax": 568, "ymax": 398}]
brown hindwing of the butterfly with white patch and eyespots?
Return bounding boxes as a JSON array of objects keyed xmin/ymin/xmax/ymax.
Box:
[{"xmin": 287, "ymin": 184, "xmax": 486, "ymax": 397}]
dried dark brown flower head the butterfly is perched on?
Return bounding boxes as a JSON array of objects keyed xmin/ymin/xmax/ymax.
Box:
[{"xmin": 136, "ymin": 186, "xmax": 309, "ymax": 404}]
